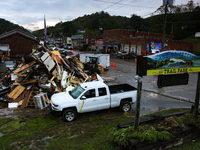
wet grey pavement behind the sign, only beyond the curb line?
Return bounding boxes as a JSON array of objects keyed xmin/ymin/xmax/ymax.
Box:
[{"xmin": 102, "ymin": 57, "xmax": 198, "ymax": 102}]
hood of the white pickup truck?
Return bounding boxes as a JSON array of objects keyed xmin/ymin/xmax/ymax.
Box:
[{"xmin": 51, "ymin": 92, "xmax": 75, "ymax": 105}]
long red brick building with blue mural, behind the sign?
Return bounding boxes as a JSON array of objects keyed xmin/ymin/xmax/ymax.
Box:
[{"xmin": 103, "ymin": 29, "xmax": 197, "ymax": 55}]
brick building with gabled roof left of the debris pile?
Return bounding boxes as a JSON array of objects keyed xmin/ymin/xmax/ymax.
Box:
[{"xmin": 0, "ymin": 29, "xmax": 39, "ymax": 57}]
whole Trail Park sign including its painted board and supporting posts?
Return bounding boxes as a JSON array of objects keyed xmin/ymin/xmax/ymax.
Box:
[{"xmin": 135, "ymin": 51, "xmax": 200, "ymax": 128}]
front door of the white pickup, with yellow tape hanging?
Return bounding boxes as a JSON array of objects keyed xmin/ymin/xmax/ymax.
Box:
[{"xmin": 78, "ymin": 89, "xmax": 97, "ymax": 113}]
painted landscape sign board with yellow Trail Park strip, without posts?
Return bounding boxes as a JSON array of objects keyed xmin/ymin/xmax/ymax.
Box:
[{"xmin": 137, "ymin": 51, "xmax": 200, "ymax": 76}]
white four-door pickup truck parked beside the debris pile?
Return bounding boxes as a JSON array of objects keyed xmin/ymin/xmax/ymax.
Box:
[{"xmin": 50, "ymin": 81, "xmax": 137, "ymax": 121}]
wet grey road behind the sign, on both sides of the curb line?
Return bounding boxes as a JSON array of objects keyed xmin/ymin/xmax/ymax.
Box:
[{"xmin": 101, "ymin": 57, "xmax": 196, "ymax": 115}]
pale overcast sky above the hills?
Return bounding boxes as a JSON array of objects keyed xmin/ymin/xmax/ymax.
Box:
[{"xmin": 0, "ymin": 0, "xmax": 197, "ymax": 31}]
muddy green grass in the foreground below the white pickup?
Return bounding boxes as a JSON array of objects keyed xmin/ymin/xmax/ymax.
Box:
[{"xmin": 0, "ymin": 109, "xmax": 200, "ymax": 150}]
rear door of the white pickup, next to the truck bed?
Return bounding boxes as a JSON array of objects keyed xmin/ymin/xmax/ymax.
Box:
[{"xmin": 97, "ymin": 87, "xmax": 110, "ymax": 110}]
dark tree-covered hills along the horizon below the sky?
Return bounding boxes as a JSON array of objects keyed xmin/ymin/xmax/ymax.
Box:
[{"xmin": 0, "ymin": 1, "xmax": 200, "ymax": 40}]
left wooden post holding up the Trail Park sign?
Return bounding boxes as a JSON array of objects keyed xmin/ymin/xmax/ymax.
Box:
[{"xmin": 134, "ymin": 76, "xmax": 142, "ymax": 130}]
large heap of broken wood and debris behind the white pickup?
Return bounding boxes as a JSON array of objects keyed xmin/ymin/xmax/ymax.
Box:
[{"xmin": 1, "ymin": 46, "xmax": 102, "ymax": 109}]
